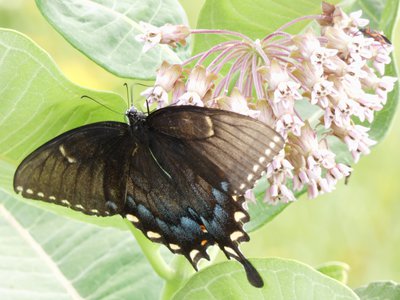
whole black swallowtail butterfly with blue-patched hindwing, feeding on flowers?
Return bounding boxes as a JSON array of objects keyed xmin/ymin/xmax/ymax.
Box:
[{"xmin": 14, "ymin": 106, "xmax": 284, "ymax": 287}]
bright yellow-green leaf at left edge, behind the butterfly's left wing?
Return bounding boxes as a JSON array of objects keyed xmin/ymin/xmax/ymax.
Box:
[{"xmin": 0, "ymin": 29, "xmax": 126, "ymax": 226}]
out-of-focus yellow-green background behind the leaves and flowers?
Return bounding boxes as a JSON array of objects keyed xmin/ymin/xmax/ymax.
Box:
[{"xmin": 0, "ymin": 0, "xmax": 400, "ymax": 287}]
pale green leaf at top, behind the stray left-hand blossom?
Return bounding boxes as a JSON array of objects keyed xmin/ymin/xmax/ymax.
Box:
[{"xmin": 36, "ymin": 0, "xmax": 189, "ymax": 79}]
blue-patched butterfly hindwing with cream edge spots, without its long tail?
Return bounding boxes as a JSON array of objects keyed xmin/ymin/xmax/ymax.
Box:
[{"xmin": 126, "ymin": 136, "xmax": 249, "ymax": 268}]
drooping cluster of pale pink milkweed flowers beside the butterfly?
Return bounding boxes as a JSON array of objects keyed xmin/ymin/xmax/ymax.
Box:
[{"xmin": 138, "ymin": 3, "xmax": 396, "ymax": 204}]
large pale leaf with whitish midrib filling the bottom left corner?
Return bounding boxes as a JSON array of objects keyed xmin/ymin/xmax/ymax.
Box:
[{"xmin": 0, "ymin": 190, "xmax": 162, "ymax": 300}]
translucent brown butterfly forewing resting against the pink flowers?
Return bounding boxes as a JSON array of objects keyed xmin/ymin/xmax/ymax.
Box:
[{"xmin": 148, "ymin": 106, "xmax": 284, "ymax": 195}]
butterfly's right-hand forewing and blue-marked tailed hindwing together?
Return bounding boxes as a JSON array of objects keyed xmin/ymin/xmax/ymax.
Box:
[{"xmin": 126, "ymin": 106, "xmax": 283, "ymax": 286}]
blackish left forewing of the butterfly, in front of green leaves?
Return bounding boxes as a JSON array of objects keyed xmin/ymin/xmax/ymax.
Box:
[{"xmin": 14, "ymin": 122, "xmax": 136, "ymax": 216}]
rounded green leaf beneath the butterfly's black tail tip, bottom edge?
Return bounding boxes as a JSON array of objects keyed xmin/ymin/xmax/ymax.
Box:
[{"xmin": 173, "ymin": 258, "xmax": 358, "ymax": 300}]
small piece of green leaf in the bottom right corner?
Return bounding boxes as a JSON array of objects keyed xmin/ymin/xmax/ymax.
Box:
[{"xmin": 355, "ymin": 281, "xmax": 400, "ymax": 300}]
